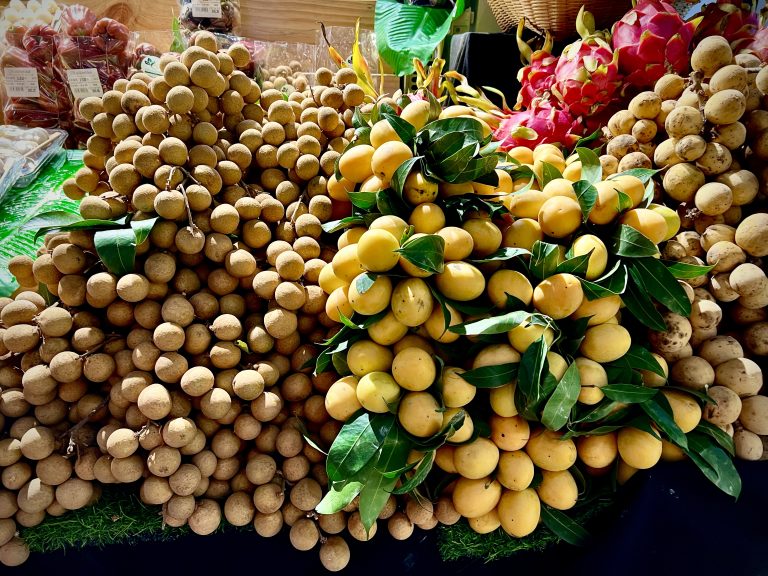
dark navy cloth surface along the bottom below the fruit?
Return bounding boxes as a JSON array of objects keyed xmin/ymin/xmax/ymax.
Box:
[{"xmin": 13, "ymin": 462, "xmax": 768, "ymax": 576}]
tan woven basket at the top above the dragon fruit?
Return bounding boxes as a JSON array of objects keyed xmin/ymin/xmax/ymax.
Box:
[{"xmin": 488, "ymin": 0, "xmax": 632, "ymax": 41}]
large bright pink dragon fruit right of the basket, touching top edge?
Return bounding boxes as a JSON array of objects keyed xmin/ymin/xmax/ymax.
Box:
[{"xmin": 613, "ymin": 0, "xmax": 696, "ymax": 90}]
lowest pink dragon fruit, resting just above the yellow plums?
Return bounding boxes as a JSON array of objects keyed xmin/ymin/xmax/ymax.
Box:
[{"xmin": 493, "ymin": 99, "xmax": 582, "ymax": 150}]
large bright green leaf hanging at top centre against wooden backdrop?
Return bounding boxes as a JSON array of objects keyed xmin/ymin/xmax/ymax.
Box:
[{"xmin": 374, "ymin": 0, "xmax": 464, "ymax": 76}]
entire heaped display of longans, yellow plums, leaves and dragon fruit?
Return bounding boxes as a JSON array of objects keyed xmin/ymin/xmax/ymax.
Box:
[{"xmin": 0, "ymin": 0, "xmax": 768, "ymax": 571}]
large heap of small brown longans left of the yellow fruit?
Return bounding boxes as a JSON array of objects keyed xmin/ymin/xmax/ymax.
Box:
[{"xmin": 0, "ymin": 32, "xmax": 394, "ymax": 570}]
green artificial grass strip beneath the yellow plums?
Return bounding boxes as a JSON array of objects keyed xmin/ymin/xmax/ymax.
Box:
[{"xmin": 437, "ymin": 499, "xmax": 612, "ymax": 562}]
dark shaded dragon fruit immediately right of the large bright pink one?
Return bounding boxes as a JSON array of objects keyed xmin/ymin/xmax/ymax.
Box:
[{"xmin": 693, "ymin": 0, "xmax": 760, "ymax": 53}]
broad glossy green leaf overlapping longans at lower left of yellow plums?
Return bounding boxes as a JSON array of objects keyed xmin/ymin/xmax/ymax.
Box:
[{"xmin": 325, "ymin": 412, "xmax": 395, "ymax": 482}]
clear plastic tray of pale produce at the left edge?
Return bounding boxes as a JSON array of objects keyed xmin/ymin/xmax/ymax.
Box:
[{"xmin": 0, "ymin": 126, "xmax": 67, "ymax": 187}]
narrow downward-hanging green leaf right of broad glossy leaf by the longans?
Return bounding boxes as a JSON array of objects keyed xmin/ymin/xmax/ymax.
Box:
[{"xmin": 359, "ymin": 424, "xmax": 411, "ymax": 532}]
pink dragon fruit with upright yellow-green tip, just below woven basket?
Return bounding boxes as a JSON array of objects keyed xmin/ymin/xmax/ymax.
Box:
[{"xmin": 551, "ymin": 7, "xmax": 621, "ymax": 117}]
